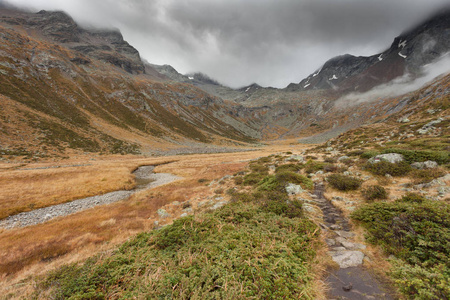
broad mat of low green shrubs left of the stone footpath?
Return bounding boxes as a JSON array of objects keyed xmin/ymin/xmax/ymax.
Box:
[{"xmin": 38, "ymin": 203, "xmax": 320, "ymax": 299}]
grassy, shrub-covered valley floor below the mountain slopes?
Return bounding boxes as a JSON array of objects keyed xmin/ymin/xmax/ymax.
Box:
[{"xmin": 0, "ymin": 136, "xmax": 449, "ymax": 299}]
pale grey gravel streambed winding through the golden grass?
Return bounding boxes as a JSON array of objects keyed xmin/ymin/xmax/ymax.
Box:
[{"xmin": 0, "ymin": 166, "xmax": 181, "ymax": 229}]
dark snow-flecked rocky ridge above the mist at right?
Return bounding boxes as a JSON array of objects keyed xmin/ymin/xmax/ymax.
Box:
[{"xmin": 294, "ymin": 10, "xmax": 450, "ymax": 93}]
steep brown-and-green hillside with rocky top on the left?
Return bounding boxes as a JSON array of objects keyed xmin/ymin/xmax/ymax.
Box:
[{"xmin": 0, "ymin": 10, "xmax": 259, "ymax": 157}]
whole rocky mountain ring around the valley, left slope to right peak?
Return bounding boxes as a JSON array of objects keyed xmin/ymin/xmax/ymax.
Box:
[{"xmin": 0, "ymin": 8, "xmax": 450, "ymax": 157}]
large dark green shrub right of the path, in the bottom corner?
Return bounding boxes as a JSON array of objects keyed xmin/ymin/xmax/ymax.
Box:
[{"xmin": 351, "ymin": 198, "xmax": 450, "ymax": 299}]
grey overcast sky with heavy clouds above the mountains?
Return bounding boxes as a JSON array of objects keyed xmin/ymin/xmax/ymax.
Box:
[{"xmin": 0, "ymin": 0, "xmax": 448, "ymax": 87}]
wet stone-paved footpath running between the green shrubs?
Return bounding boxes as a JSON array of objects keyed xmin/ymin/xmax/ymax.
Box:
[{"xmin": 314, "ymin": 183, "xmax": 395, "ymax": 299}]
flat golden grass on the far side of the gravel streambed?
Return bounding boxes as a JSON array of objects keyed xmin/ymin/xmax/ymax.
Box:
[{"xmin": 0, "ymin": 158, "xmax": 177, "ymax": 219}]
